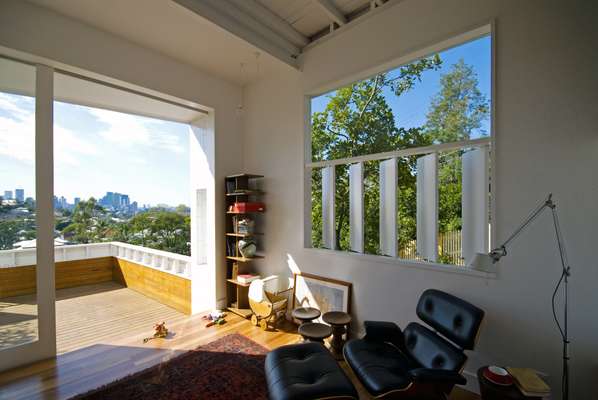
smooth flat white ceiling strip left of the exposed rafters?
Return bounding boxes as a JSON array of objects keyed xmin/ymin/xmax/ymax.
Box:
[{"xmin": 30, "ymin": 0, "xmax": 291, "ymax": 85}]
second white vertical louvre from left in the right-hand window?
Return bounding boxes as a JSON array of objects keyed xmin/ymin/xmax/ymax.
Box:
[{"xmin": 349, "ymin": 163, "xmax": 363, "ymax": 253}]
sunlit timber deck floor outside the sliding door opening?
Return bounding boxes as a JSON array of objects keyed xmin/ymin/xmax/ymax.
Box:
[{"xmin": 0, "ymin": 282, "xmax": 187, "ymax": 354}]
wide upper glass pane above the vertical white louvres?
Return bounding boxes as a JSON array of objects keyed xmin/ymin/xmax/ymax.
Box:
[{"xmin": 311, "ymin": 36, "xmax": 492, "ymax": 161}]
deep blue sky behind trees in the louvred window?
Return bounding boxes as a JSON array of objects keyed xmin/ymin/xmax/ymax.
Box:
[{"xmin": 311, "ymin": 36, "xmax": 492, "ymax": 137}]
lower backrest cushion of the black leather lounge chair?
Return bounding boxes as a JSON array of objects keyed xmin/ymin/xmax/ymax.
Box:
[{"xmin": 405, "ymin": 322, "xmax": 467, "ymax": 371}]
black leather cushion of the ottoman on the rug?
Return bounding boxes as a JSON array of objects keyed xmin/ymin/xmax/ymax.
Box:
[{"xmin": 265, "ymin": 343, "xmax": 358, "ymax": 400}]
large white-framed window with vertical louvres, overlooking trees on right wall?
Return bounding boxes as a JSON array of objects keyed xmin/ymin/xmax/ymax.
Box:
[{"xmin": 306, "ymin": 35, "xmax": 492, "ymax": 265}]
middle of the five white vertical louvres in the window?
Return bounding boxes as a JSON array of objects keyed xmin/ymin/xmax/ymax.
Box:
[{"xmin": 380, "ymin": 158, "xmax": 397, "ymax": 257}]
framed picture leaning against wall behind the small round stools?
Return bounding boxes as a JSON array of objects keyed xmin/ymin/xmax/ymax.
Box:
[{"xmin": 293, "ymin": 272, "xmax": 351, "ymax": 322}]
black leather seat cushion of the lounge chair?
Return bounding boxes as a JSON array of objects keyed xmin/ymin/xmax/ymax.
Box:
[{"xmin": 343, "ymin": 339, "xmax": 419, "ymax": 396}]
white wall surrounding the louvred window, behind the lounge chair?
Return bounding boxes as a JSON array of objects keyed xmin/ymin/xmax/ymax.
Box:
[{"xmin": 244, "ymin": 0, "xmax": 598, "ymax": 399}]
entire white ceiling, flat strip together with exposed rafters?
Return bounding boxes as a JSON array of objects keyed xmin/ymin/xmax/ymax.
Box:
[{"xmin": 28, "ymin": 0, "xmax": 386, "ymax": 85}]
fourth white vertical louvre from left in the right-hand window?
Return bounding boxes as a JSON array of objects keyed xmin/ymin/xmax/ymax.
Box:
[{"xmin": 417, "ymin": 153, "xmax": 438, "ymax": 262}]
